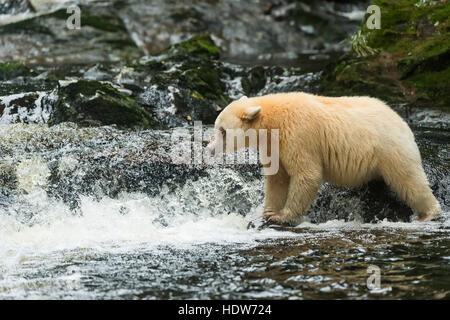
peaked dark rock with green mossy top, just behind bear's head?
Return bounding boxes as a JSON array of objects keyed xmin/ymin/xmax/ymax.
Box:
[{"xmin": 132, "ymin": 34, "xmax": 227, "ymax": 125}]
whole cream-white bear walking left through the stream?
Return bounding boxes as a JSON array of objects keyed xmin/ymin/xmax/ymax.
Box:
[{"xmin": 208, "ymin": 92, "xmax": 440, "ymax": 224}]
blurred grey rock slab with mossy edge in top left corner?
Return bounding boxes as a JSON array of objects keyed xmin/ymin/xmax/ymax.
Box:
[{"xmin": 0, "ymin": 3, "xmax": 141, "ymax": 64}]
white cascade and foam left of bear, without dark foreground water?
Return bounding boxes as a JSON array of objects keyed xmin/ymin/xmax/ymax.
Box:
[{"xmin": 0, "ymin": 124, "xmax": 450, "ymax": 276}]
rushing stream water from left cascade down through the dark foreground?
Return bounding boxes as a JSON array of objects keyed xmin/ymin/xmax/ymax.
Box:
[{"xmin": 0, "ymin": 124, "xmax": 450, "ymax": 299}]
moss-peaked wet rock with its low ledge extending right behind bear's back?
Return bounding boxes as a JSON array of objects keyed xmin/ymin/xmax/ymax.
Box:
[{"xmin": 130, "ymin": 35, "xmax": 320, "ymax": 126}]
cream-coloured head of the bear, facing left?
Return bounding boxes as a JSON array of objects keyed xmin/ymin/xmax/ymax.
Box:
[{"xmin": 208, "ymin": 96, "xmax": 262, "ymax": 154}]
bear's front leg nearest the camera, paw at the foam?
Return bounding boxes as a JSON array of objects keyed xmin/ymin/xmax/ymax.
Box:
[{"xmin": 267, "ymin": 172, "xmax": 322, "ymax": 224}]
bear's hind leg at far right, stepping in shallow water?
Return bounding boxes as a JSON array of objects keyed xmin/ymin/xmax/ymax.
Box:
[{"xmin": 382, "ymin": 165, "xmax": 441, "ymax": 221}]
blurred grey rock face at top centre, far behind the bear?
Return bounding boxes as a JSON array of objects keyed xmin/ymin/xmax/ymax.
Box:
[{"xmin": 120, "ymin": 0, "xmax": 369, "ymax": 60}]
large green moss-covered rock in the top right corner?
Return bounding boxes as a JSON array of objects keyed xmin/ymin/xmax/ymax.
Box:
[{"xmin": 321, "ymin": 0, "xmax": 450, "ymax": 111}]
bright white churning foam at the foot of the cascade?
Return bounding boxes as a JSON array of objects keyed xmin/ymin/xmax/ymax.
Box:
[{"xmin": 0, "ymin": 165, "xmax": 450, "ymax": 272}]
